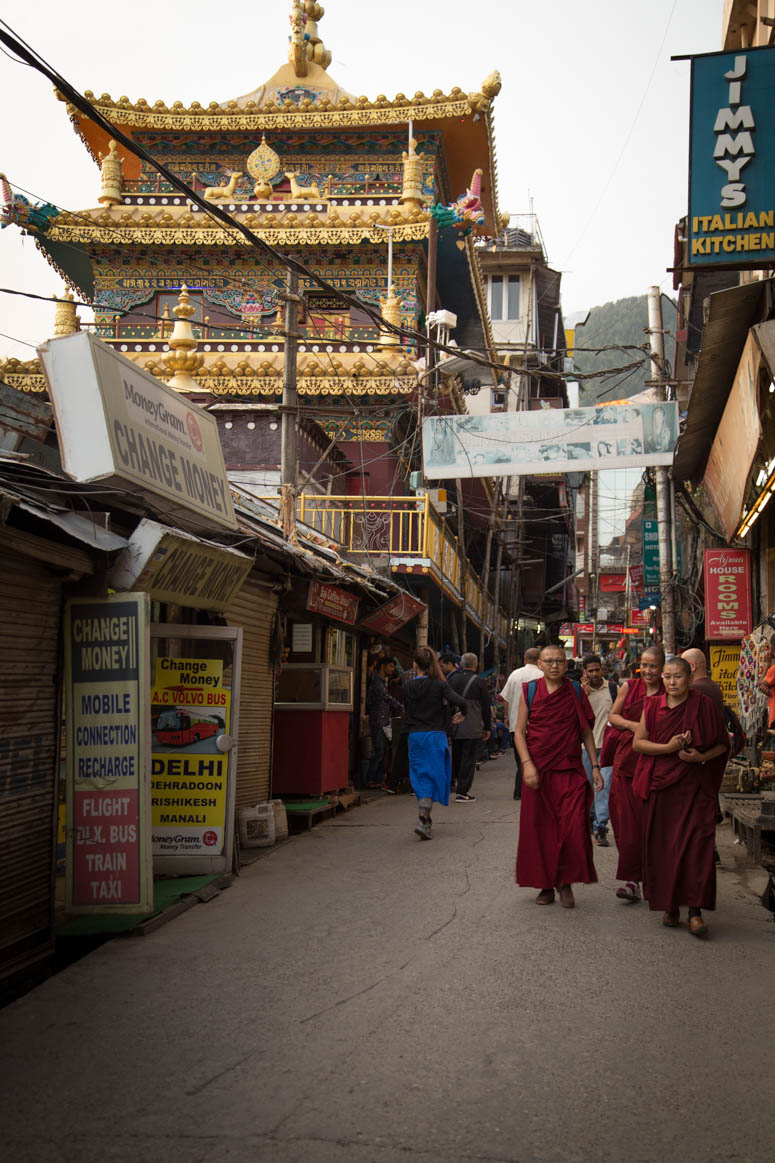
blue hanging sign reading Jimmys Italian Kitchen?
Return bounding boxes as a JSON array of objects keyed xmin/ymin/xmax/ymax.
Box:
[{"xmin": 689, "ymin": 48, "xmax": 775, "ymax": 267}]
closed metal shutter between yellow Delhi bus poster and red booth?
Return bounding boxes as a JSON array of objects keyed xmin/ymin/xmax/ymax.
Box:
[{"xmin": 226, "ymin": 578, "xmax": 277, "ymax": 808}]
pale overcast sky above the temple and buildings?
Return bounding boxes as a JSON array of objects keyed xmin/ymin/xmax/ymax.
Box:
[{"xmin": 0, "ymin": 0, "xmax": 723, "ymax": 358}]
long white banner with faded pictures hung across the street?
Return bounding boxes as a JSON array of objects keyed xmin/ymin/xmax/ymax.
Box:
[{"xmin": 422, "ymin": 402, "xmax": 678, "ymax": 480}]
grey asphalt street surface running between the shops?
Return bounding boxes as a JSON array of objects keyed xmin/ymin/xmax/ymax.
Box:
[{"xmin": 0, "ymin": 757, "xmax": 775, "ymax": 1163}]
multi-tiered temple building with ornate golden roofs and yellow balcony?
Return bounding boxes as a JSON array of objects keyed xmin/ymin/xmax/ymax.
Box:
[{"xmin": 2, "ymin": 0, "xmax": 512, "ymax": 643}]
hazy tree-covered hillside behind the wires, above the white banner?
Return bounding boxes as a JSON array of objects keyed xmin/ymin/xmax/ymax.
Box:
[{"xmin": 574, "ymin": 295, "xmax": 676, "ymax": 407}]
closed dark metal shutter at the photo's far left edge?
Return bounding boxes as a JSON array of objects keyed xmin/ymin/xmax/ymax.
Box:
[{"xmin": 0, "ymin": 556, "xmax": 62, "ymax": 977}]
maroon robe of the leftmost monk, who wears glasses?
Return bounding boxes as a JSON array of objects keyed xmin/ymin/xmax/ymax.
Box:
[{"xmin": 517, "ymin": 678, "xmax": 597, "ymax": 889}]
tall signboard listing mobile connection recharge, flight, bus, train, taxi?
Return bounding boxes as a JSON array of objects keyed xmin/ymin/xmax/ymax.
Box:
[{"xmin": 65, "ymin": 593, "xmax": 154, "ymax": 913}]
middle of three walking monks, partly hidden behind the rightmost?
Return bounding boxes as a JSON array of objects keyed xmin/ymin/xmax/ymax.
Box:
[{"xmin": 609, "ymin": 647, "xmax": 664, "ymax": 904}]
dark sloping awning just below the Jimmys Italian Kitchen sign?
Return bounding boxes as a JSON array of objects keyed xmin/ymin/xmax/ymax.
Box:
[{"xmin": 673, "ymin": 280, "xmax": 769, "ymax": 481}]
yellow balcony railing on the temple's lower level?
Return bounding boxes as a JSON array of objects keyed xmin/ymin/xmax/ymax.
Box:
[{"xmin": 299, "ymin": 493, "xmax": 507, "ymax": 638}]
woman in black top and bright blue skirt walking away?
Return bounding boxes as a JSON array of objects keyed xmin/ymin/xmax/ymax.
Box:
[{"xmin": 397, "ymin": 647, "xmax": 468, "ymax": 840}]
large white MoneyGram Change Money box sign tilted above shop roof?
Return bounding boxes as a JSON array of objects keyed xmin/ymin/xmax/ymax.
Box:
[{"xmin": 38, "ymin": 331, "xmax": 236, "ymax": 529}]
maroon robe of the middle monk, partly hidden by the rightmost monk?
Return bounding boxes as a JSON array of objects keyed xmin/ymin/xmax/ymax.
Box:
[{"xmin": 609, "ymin": 678, "xmax": 663, "ymax": 882}]
